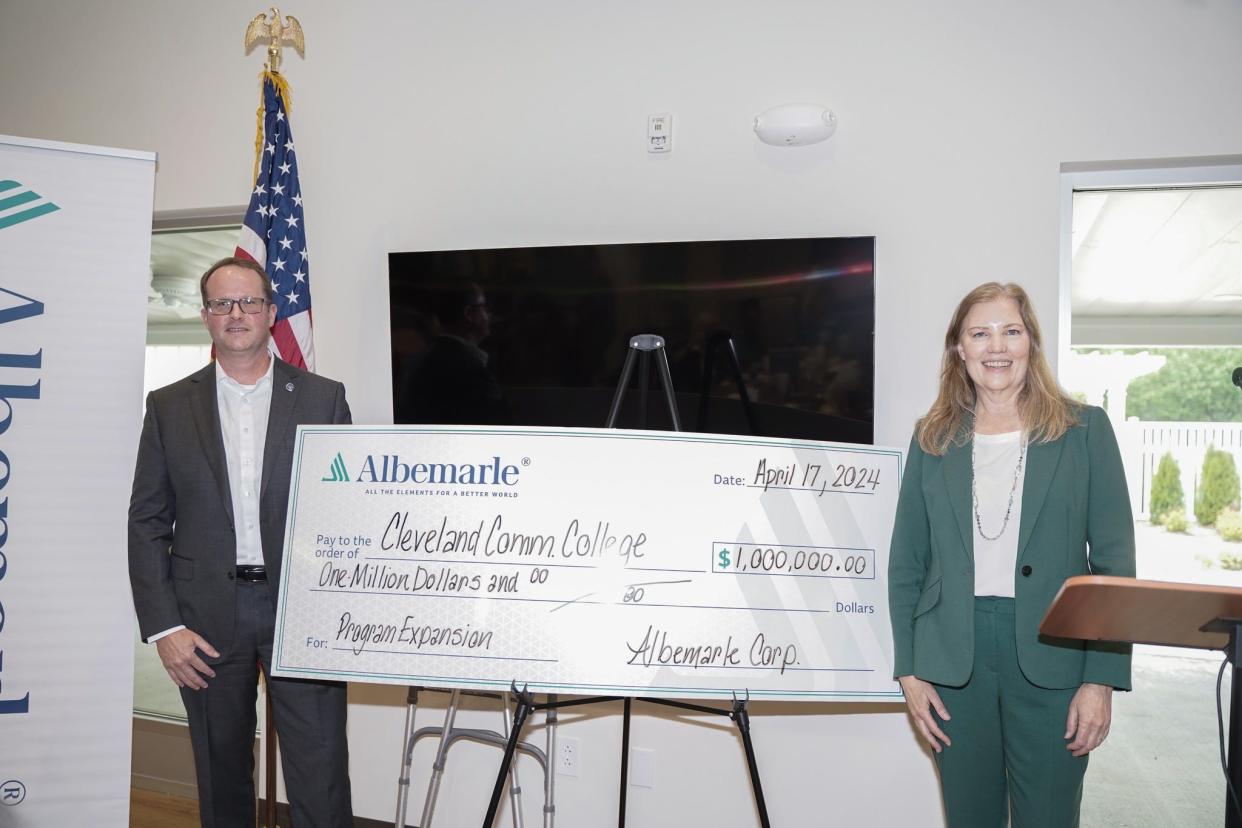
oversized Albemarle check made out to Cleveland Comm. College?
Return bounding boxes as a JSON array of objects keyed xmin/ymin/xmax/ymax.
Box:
[{"xmin": 273, "ymin": 426, "xmax": 904, "ymax": 701}]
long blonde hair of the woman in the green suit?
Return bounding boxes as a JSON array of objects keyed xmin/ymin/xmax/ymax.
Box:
[{"xmin": 918, "ymin": 282, "xmax": 1078, "ymax": 454}]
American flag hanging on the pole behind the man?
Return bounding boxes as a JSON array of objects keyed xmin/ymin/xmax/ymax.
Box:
[{"xmin": 236, "ymin": 72, "xmax": 314, "ymax": 371}]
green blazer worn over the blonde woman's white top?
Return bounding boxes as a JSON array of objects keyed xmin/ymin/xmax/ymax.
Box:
[{"xmin": 888, "ymin": 406, "xmax": 1134, "ymax": 690}]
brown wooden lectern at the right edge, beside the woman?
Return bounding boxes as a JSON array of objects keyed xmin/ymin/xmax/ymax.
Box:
[{"xmin": 1040, "ymin": 575, "xmax": 1242, "ymax": 828}]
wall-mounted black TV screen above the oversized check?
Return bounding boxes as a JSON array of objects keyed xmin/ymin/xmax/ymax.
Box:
[{"xmin": 389, "ymin": 237, "xmax": 876, "ymax": 443}]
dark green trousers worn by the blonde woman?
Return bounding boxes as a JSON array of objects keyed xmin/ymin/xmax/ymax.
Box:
[{"xmin": 936, "ymin": 597, "xmax": 1087, "ymax": 828}]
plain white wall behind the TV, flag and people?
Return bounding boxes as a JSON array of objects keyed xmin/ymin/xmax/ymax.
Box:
[{"xmin": 0, "ymin": 0, "xmax": 1242, "ymax": 827}]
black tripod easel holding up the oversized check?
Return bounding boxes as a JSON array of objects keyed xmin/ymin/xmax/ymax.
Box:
[{"xmin": 483, "ymin": 334, "xmax": 771, "ymax": 828}]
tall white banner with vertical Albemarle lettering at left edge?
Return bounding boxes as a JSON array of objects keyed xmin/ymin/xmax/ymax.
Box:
[{"xmin": 0, "ymin": 135, "xmax": 155, "ymax": 828}]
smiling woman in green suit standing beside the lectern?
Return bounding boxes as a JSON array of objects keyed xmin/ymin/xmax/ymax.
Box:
[{"xmin": 888, "ymin": 282, "xmax": 1134, "ymax": 828}]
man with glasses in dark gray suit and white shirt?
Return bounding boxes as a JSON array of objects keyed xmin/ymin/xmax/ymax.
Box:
[{"xmin": 129, "ymin": 257, "xmax": 353, "ymax": 828}]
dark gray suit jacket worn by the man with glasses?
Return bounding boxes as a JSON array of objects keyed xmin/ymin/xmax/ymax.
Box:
[{"xmin": 129, "ymin": 360, "xmax": 350, "ymax": 657}]
